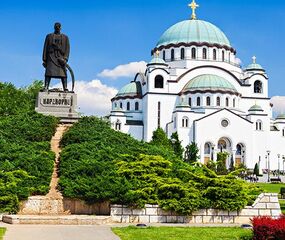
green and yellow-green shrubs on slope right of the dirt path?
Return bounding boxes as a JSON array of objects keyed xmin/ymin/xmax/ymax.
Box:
[{"xmin": 59, "ymin": 117, "xmax": 259, "ymax": 214}]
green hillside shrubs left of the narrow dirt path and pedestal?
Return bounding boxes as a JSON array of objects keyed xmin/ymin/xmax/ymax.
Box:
[{"xmin": 0, "ymin": 82, "xmax": 58, "ymax": 213}]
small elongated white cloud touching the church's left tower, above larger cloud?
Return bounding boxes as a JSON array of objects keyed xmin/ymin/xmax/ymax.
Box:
[{"xmin": 98, "ymin": 61, "xmax": 147, "ymax": 79}]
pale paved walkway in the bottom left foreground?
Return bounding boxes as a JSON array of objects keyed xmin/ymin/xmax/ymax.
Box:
[{"xmin": 0, "ymin": 223, "xmax": 120, "ymax": 240}]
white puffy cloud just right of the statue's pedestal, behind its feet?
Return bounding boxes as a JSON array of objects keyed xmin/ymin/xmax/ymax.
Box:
[{"xmin": 52, "ymin": 79, "xmax": 118, "ymax": 116}]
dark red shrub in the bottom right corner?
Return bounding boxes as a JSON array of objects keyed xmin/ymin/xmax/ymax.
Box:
[{"xmin": 252, "ymin": 216, "xmax": 285, "ymax": 240}]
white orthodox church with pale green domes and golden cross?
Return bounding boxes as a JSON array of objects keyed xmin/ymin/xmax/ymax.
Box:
[{"xmin": 110, "ymin": 1, "xmax": 285, "ymax": 170}]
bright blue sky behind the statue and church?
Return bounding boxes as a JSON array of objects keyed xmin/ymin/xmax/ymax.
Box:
[{"xmin": 0, "ymin": 0, "xmax": 285, "ymax": 114}]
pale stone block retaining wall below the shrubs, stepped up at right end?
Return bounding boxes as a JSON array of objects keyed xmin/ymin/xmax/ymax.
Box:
[{"xmin": 111, "ymin": 193, "xmax": 281, "ymax": 224}]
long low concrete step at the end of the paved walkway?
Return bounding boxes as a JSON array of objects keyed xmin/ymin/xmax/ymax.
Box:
[{"xmin": 2, "ymin": 215, "xmax": 111, "ymax": 225}]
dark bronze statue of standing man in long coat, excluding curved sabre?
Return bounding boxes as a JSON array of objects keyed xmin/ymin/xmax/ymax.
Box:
[{"xmin": 43, "ymin": 23, "xmax": 70, "ymax": 91}]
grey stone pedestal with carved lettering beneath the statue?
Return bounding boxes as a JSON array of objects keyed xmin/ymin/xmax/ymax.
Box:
[{"xmin": 36, "ymin": 91, "xmax": 79, "ymax": 121}]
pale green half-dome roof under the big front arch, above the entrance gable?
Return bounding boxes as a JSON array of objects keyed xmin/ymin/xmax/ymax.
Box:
[{"xmin": 183, "ymin": 74, "xmax": 238, "ymax": 94}]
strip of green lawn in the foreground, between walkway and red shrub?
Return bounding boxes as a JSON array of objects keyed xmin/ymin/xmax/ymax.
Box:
[{"xmin": 112, "ymin": 226, "xmax": 252, "ymax": 240}]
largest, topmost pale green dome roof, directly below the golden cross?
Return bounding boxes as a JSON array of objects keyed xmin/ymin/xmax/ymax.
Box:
[{"xmin": 156, "ymin": 20, "xmax": 231, "ymax": 48}]
